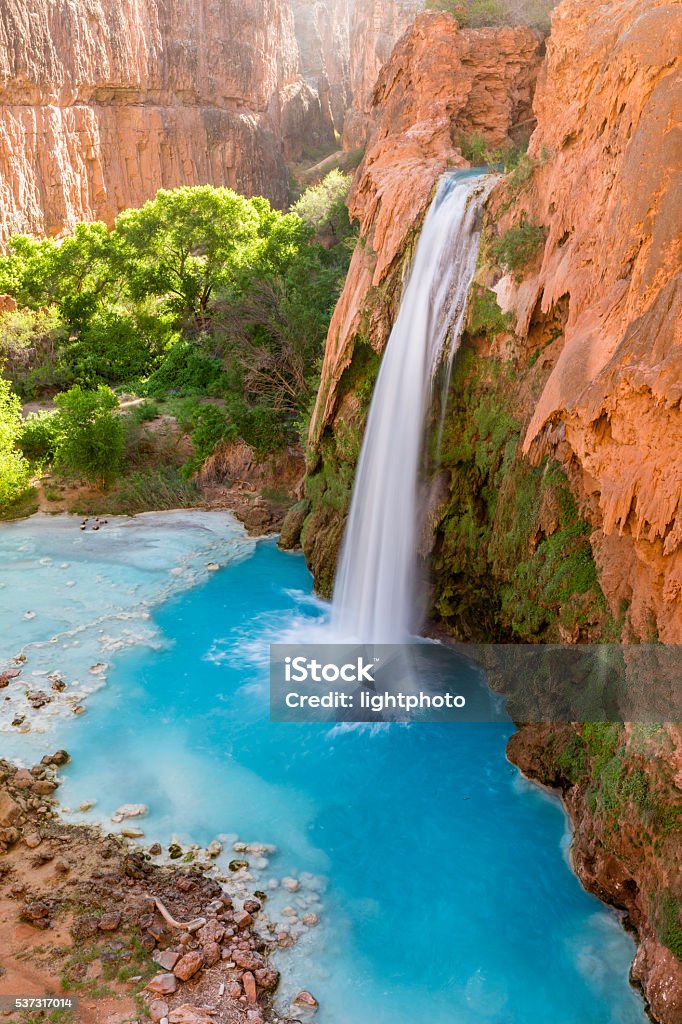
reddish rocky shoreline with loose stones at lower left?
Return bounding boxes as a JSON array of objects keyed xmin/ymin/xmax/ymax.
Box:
[{"xmin": 0, "ymin": 751, "xmax": 316, "ymax": 1024}]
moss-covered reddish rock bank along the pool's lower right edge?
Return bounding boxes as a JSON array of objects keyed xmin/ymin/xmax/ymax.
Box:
[{"xmin": 509, "ymin": 722, "xmax": 682, "ymax": 959}]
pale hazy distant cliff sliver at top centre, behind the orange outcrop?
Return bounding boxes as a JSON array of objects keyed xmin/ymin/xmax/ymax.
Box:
[{"xmin": 343, "ymin": 0, "xmax": 424, "ymax": 150}]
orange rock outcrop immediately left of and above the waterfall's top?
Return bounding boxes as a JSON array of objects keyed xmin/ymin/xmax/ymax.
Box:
[{"xmin": 310, "ymin": 12, "xmax": 541, "ymax": 446}]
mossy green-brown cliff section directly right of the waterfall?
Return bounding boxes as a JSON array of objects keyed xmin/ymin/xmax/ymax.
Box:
[{"xmin": 434, "ymin": 341, "xmax": 606, "ymax": 641}]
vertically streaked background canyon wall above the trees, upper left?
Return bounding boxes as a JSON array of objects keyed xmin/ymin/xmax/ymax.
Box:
[{"xmin": 0, "ymin": 0, "xmax": 331, "ymax": 237}]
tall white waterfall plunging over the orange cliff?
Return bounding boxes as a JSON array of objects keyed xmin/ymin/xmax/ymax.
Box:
[{"xmin": 332, "ymin": 171, "xmax": 493, "ymax": 643}]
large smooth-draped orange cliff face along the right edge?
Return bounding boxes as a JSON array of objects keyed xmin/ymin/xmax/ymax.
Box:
[{"xmin": 497, "ymin": 0, "xmax": 682, "ymax": 643}]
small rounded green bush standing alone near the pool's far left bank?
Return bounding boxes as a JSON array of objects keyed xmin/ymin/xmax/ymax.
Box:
[{"xmin": 54, "ymin": 385, "xmax": 124, "ymax": 487}]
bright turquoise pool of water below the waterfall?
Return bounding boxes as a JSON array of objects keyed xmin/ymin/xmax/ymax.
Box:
[{"xmin": 0, "ymin": 523, "xmax": 645, "ymax": 1024}]
